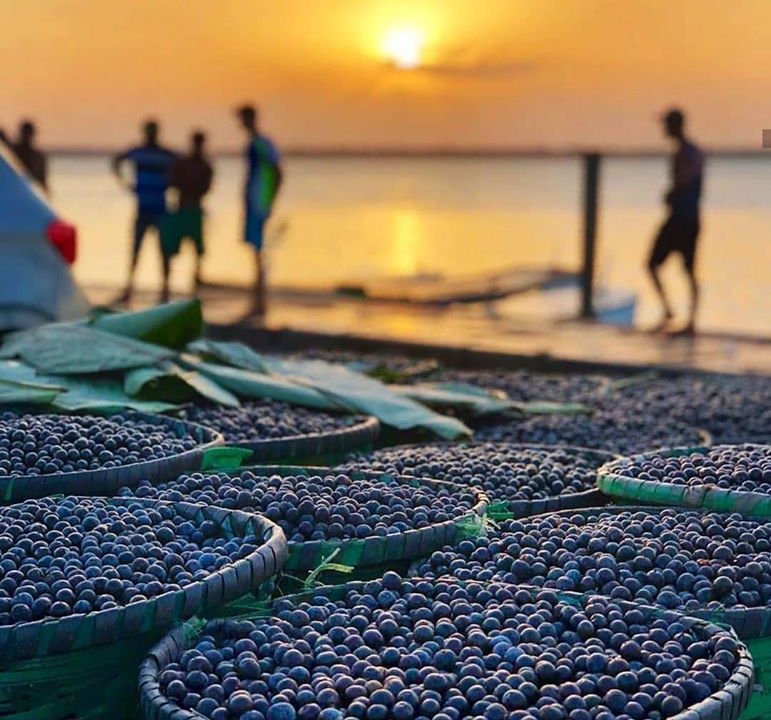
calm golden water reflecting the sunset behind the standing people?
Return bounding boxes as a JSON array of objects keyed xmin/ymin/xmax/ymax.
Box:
[{"xmin": 51, "ymin": 157, "xmax": 771, "ymax": 335}]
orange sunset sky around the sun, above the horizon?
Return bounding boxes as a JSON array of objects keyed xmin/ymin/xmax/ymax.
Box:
[{"xmin": 6, "ymin": 0, "xmax": 771, "ymax": 147}]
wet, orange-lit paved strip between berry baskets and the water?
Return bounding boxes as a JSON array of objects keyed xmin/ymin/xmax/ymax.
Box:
[{"xmin": 81, "ymin": 287, "xmax": 771, "ymax": 377}]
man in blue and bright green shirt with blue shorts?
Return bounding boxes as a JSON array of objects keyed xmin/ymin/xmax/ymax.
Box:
[{"xmin": 238, "ymin": 105, "xmax": 283, "ymax": 315}]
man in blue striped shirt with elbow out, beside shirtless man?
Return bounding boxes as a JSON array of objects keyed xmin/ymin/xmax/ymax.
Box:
[{"xmin": 112, "ymin": 120, "xmax": 175, "ymax": 300}]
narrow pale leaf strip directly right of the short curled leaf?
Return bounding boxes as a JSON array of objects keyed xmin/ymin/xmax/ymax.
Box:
[{"xmin": 180, "ymin": 354, "xmax": 351, "ymax": 412}]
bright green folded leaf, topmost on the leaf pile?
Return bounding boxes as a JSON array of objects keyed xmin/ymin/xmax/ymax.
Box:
[{"xmin": 90, "ymin": 299, "xmax": 203, "ymax": 350}]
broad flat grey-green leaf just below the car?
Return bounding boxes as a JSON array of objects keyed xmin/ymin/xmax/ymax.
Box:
[{"xmin": 0, "ymin": 323, "xmax": 174, "ymax": 375}]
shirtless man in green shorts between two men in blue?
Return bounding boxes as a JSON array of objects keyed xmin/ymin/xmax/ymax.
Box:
[{"xmin": 161, "ymin": 132, "xmax": 214, "ymax": 302}]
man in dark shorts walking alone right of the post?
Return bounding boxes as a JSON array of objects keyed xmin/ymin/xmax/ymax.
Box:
[{"xmin": 648, "ymin": 109, "xmax": 704, "ymax": 334}]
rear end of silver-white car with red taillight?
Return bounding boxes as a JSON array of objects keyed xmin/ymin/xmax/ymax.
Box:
[{"xmin": 0, "ymin": 143, "xmax": 88, "ymax": 332}]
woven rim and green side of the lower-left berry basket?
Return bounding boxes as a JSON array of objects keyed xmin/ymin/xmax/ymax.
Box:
[{"xmin": 0, "ymin": 499, "xmax": 287, "ymax": 720}]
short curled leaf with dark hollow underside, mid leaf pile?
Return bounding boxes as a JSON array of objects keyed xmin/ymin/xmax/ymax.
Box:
[{"xmin": 123, "ymin": 362, "xmax": 241, "ymax": 407}]
